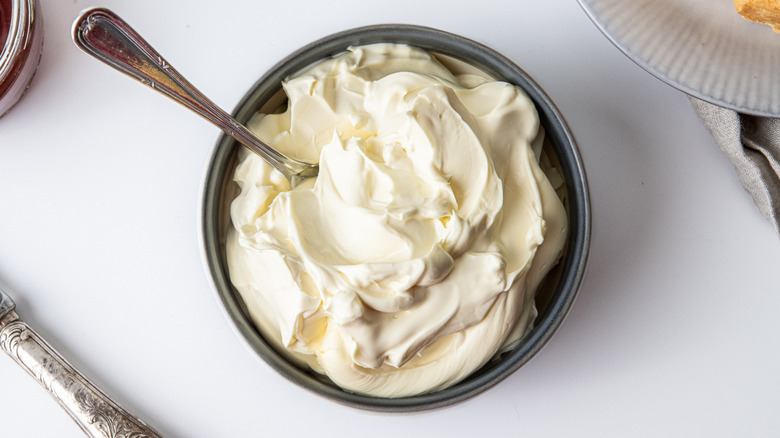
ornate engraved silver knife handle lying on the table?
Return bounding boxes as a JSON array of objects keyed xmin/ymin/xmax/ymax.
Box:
[{"xmin": 0, "ymin": 290, "xmax": 161, "ymax": 438}]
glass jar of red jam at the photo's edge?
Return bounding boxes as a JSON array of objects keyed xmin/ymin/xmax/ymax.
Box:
[{"xmin": 0, "ymin": 0, "xmax": 43, "ymax": 117}]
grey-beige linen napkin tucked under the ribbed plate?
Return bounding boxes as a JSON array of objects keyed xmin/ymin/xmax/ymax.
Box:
[{"xmin": 691, "ymin": 97, "xmax": 780, "ymax": 232}]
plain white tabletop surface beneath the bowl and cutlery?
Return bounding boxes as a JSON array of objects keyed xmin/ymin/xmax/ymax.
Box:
[{"xmin": 0, "ymin": 0, "xmax": 780, "ymax": 438}]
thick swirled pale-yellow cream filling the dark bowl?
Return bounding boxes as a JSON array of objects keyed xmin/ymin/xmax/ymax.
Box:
[{"xmin": 227, "ymin": 44, "xmax": 567, "ymax": 397}]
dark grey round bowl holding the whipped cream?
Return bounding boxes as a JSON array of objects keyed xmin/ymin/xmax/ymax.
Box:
[{"xmin": 201, "ymin": 24, "xmax": 591, "ymax": 412}]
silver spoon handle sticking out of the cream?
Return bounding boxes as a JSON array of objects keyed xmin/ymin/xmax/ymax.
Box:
[{"xmin": 73, "ymin": 8, "xmax": 319, "ymax": 186}]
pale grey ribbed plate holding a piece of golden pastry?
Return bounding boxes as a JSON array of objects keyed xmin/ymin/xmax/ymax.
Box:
[{"xmin": 579, "ymin": 0, "xmax": 780, "ymax": 117}]
